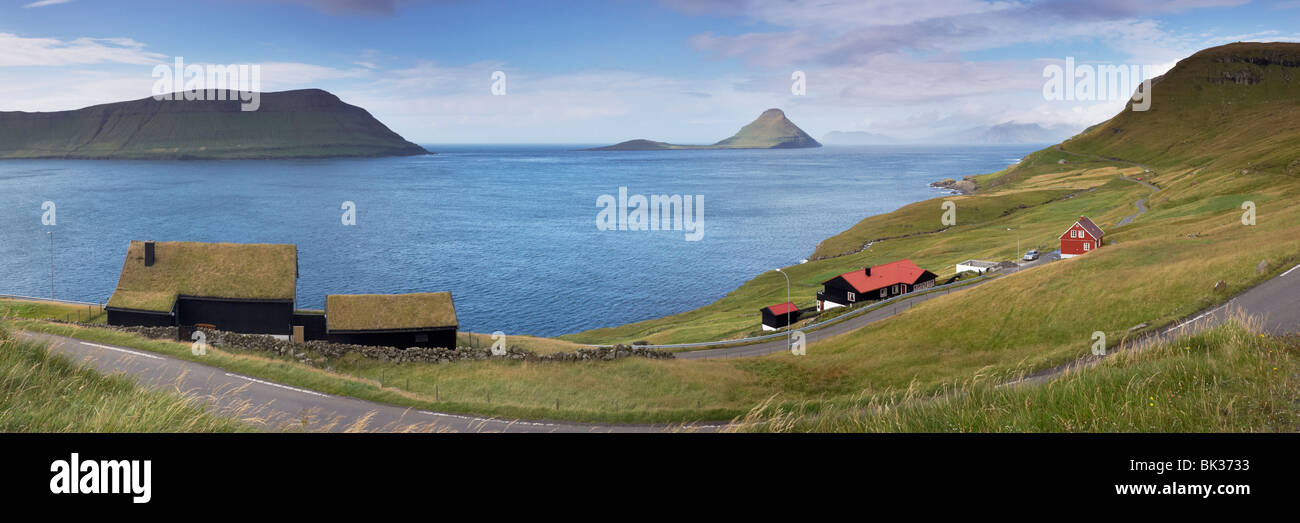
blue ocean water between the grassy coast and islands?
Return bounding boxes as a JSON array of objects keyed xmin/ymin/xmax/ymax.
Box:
[{"xmin": 0, "ymin": 146, "xmax": 1039, "ymax": 336}]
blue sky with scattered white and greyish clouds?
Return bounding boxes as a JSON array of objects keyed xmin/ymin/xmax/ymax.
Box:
[{"xmin": 0, "ymin": 0, "xmax": 1300, "ymax": 144}]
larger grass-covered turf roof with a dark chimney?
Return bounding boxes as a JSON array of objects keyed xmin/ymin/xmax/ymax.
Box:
[{"xmin": 108, "ymin": 241, "xmax": 298, "ymax": 312}]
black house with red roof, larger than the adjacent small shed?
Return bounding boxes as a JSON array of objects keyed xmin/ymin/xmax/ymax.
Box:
[{"xmin": 816, "ymin": 259, "xmax": 939, "ymax": 311}]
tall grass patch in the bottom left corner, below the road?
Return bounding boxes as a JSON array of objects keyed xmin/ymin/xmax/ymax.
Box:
[{"xmin": 0, "ymin": 328, "xmax": 252, "ymax": 432}]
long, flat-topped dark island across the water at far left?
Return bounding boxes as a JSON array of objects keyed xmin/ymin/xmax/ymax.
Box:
[{"xmin": 0, "ymin": 88, "xmax": 429, "ymax": 160}]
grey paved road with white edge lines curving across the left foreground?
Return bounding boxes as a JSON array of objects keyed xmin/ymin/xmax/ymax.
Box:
[{"xmin": 21, "ymin": 332, "xmax": 724, "ymax": 432}]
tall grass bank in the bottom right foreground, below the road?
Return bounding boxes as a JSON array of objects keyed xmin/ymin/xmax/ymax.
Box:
[{"xmin": 735, "ymin": 323, "xmax": 1300, "ymax": 432}]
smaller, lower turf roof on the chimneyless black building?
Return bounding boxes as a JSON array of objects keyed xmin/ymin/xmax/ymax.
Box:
[{"xmin": 325, "ymin": 293, "xmax": 460, "ymax": 332}]
